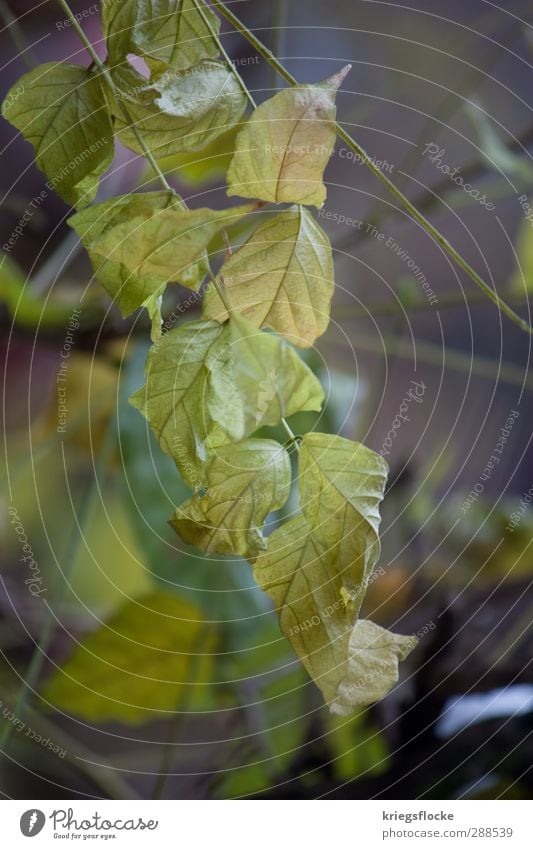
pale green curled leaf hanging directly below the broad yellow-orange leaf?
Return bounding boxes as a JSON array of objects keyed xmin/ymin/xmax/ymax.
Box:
[{"xmin": 208, "ymin": 313, "xmax": 324, "ymax": 441}]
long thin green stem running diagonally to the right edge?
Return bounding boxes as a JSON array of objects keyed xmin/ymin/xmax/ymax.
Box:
[{"xmin": 212, "ymin": 0, "xmax": 533, "ymax": 334}]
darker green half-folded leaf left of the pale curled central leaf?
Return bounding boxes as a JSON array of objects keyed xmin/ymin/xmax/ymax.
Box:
[{"xmin": 130, "ymin": 321, "xmax": 227, "ymax": 489}]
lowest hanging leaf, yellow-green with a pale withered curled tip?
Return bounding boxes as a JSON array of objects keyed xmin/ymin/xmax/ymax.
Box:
[{"xmin": 254, "ymin": 515, "xmax": 416, "ymax": 715}]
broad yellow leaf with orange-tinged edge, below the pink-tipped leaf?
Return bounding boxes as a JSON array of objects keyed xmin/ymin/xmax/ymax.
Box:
[{"xmin": 203, "ymin": 206, "xmax": 335, "ymax": 348}]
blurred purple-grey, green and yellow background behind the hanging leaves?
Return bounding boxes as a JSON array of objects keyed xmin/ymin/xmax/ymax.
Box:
[{"xmin": 0, "ymin": 0, "xmax": 533, "ymax": 799}]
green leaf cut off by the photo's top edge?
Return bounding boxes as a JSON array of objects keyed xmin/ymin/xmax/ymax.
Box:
[{"xmin": 102, "ymin": 0, "xmax": 220, "ymax": 70}]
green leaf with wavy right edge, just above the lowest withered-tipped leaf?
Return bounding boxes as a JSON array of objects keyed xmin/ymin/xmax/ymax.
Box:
[{"xmin": 299, "ymin": 433, "xmax": 388, "ymax": 596}]
